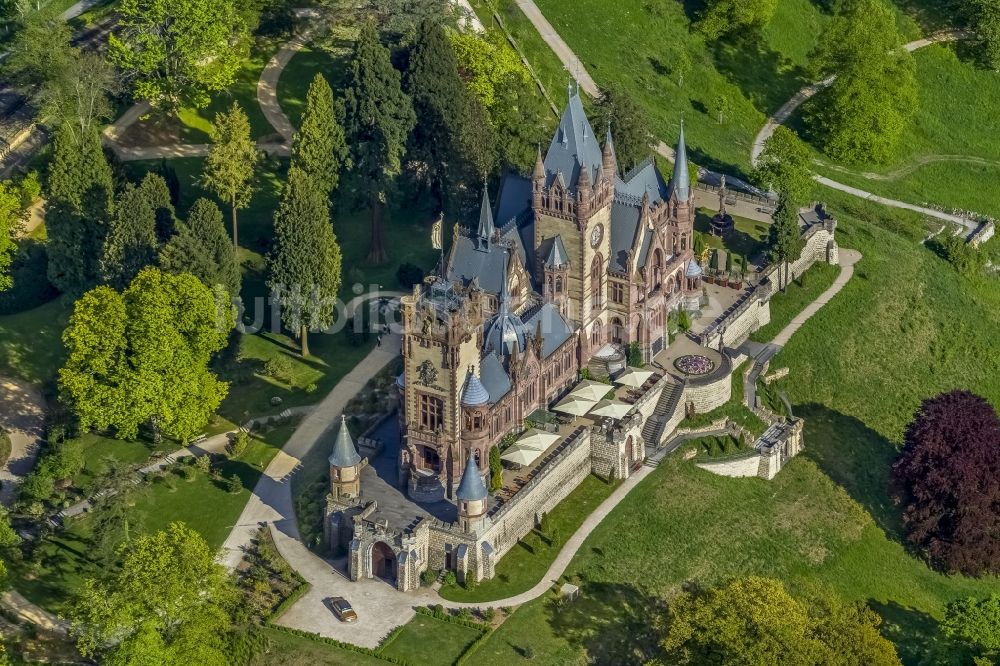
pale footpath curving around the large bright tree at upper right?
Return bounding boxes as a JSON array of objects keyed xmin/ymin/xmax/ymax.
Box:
[{"xmin": 750, "ymin": 30, "xmax": 977, "ymax": 231}]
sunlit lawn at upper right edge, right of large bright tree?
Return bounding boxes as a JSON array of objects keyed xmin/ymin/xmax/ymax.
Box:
[{"xmin": 808, "ymin": 45, "xmax": 1000, "ymax": 217}]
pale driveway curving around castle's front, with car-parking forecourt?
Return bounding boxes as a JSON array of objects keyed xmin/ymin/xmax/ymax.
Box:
[{"xmin": 256, "ymin": 253, "xmax": 861, "ymax": 648}]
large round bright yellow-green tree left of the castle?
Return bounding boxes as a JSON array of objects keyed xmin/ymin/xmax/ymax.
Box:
[{"xmin": 59, "ymin": 268, "xmax": 233, "ymax": 440}]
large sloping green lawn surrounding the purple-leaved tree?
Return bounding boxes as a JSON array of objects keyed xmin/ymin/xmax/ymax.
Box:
[{"xmin": 462, "ymin": 209, "xmax": 1000, "ymax": 665}]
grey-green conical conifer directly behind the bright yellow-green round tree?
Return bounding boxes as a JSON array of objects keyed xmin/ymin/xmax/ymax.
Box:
[{"xmin": 160, "ymin": 199, "xmax": 240, "ymax": 298}]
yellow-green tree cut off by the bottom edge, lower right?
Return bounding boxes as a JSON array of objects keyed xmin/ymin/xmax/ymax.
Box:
[{"xmin": 660, "ymin": 577, "xmax": 900, "ymax": 666}]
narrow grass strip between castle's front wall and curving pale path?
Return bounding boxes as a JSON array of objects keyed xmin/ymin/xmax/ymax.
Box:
[{"xmin": 441, "ymin": 476, "xmax": 614, "ymax": 601}]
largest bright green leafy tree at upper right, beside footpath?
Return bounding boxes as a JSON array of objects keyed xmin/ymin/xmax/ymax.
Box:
[{"xmin": 807, "ymin": 0, "xmax": 917, "ymax": 163}]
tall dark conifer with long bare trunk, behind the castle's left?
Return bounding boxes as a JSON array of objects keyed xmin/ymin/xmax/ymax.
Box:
[{"xmin": 345, "ymin": 22, "xmax": 416, "ymax": 264}]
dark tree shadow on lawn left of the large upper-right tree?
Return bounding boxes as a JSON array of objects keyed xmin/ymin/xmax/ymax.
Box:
[{"xmin": 712, "ymin": 30, "xmax": 809, "ymax": 114}]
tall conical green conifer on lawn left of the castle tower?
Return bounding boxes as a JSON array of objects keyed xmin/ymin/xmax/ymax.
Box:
[{"xmin": 268, "ymin": 166, "xmax": 341, "ymax": 356}]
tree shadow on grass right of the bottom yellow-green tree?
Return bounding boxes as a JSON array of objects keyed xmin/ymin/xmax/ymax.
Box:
[{"xmin": 868, "ymin": 599, "xmax": 973, "ymax": 666}]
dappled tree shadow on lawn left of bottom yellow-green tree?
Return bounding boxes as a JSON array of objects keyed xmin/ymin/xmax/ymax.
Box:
[{"xmin": 540, "ymin": 581, "xmax": 666, "ymax": 665}]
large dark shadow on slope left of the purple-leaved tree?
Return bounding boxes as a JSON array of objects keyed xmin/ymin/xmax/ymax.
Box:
[{"xmin": 794, "ymin": 403, "xmax": 909, "ymax": 547}]
